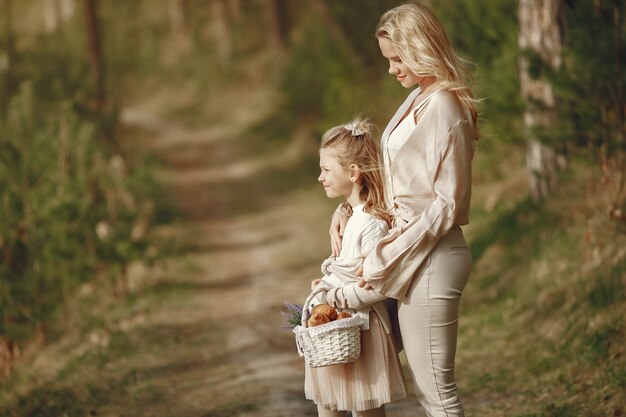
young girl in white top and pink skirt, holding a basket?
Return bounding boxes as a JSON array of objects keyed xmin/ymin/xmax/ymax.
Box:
[{"xmin": 305, "ymin": 119, "xmax": 406, "ymax": 417}]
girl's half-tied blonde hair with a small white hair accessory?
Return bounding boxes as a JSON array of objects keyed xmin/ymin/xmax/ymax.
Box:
[{"xmin": 320, "ymin": 117, "xmax": 392, "ymax": 226}]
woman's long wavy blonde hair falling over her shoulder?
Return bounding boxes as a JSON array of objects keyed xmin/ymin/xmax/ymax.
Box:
[{"xmin": 376, "ymin": 3, "xmax": 478, "ymax": 138}]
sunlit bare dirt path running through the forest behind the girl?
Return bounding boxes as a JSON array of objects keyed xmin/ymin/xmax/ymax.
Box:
[{"xmin": 117, "ymin": 83, "xmax": 424, "ymax": 417}]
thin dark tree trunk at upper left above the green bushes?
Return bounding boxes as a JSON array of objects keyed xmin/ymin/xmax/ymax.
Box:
[{"xmin": 84, "ymin": 0, "xmax": 106, "ymax": 112}]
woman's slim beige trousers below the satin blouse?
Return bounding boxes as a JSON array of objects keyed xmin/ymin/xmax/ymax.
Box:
[{"xmin": 398, "ymin": 226, "xmax": 472, "ymax": 417}]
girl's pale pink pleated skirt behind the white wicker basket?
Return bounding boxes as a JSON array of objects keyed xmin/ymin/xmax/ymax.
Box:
[{"xmin": 304, "ymin": 310, "xmax": 406, "ymax": 411}]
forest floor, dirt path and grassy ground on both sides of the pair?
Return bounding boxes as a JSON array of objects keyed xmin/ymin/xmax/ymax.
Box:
[{"xmin": 0, "ymin": 67, "xmax": 626, "ymax": 417}]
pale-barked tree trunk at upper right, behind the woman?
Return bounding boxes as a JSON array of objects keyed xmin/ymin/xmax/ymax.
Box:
[{"xmin": 519, "ymin": 0, "xmax": 565, "ymax": 201}]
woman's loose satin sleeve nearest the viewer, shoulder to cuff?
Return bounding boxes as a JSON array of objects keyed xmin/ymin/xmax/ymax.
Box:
[{"xmin": 363, "ymin": 120, "xmax": 474, "ymax": 299}]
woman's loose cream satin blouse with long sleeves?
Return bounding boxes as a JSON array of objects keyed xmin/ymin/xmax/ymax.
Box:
[{"xmin": 363, "ymin": 88, "xmax": 476, "ymax": 299}]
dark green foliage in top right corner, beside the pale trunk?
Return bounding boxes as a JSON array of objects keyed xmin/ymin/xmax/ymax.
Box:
[{"xmin": 549, "ymin": 0, "xmax": 626, "ymax": 155}]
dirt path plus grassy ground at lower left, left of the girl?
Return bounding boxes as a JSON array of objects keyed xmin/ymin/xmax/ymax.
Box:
[{"xmin": 0, "ymin": 76, "xmax": 434, "ymax": 417}]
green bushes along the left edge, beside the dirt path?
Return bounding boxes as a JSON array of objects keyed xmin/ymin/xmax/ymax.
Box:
[{"xmin": 0, "ymin": 1, "xmax": 163, "ymax": 344}]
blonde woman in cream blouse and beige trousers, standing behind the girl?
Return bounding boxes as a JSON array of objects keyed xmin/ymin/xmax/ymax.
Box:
[{"xmin": 330, "ymin": 4, "xmax": 478, "ymax": 417}]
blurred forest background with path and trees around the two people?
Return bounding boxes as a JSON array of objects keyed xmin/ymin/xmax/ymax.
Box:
[{"xmin": 0, "ymin": 0, "xmax": 626, "ymax": 417}]
